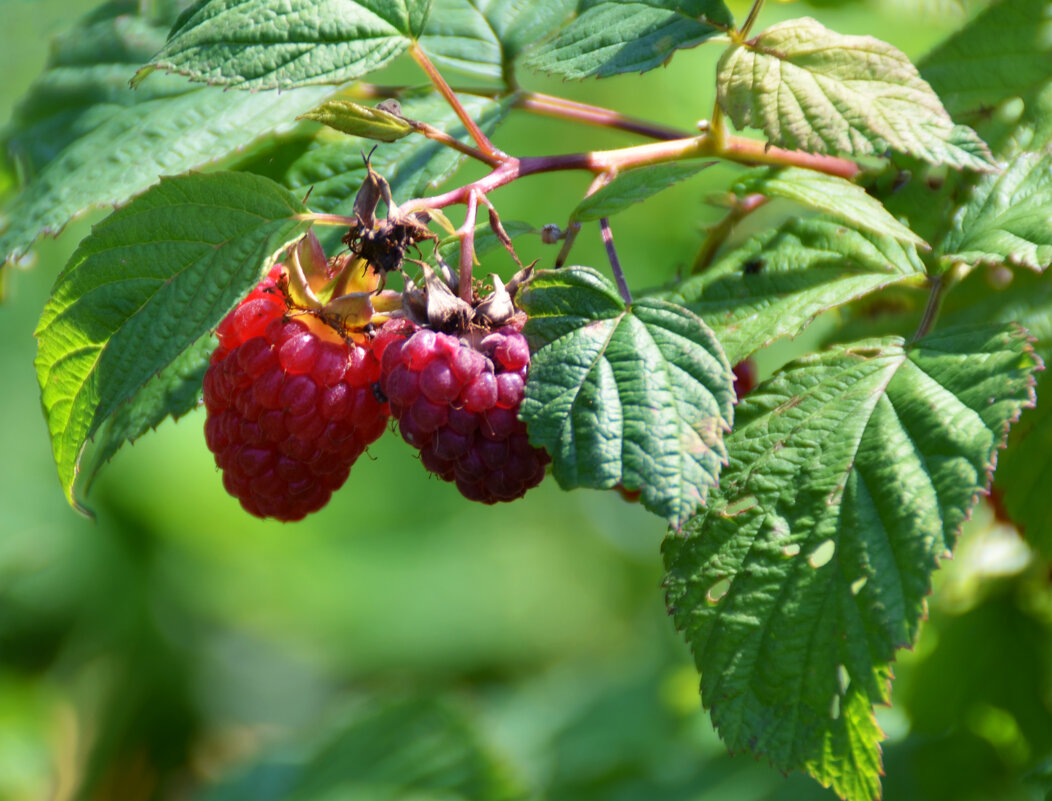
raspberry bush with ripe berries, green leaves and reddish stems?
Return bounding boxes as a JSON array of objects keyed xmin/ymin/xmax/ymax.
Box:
[{"xmin": 0, "ymin": 0, "xmax": 1052, "ymax": 801}]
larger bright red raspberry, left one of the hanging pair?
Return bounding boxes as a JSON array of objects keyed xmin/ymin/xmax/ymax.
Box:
[{"xmin": 204, "ymin": 266, "xmax": 389, "ymax": 521}]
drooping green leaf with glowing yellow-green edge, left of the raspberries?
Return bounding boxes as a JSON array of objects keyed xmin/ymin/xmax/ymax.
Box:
[{"xmin": 36, "ymin": 173, "xmax": 308, "ymax": 507}]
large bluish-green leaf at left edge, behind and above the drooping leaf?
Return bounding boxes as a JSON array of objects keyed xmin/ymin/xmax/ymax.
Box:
[{"xmin": 0, "ymin": 26, "xmax": 329, "ymax": 265}]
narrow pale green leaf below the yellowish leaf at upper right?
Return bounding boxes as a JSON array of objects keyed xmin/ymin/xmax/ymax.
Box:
[{"xmin": 732, "ymin": 167, "xmax": 926, "ymax": 247}]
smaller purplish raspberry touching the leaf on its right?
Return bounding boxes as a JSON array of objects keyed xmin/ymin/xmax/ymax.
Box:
[{"xmin": 373, "ymin": 320, "xmax": 549, "ymax": 503}]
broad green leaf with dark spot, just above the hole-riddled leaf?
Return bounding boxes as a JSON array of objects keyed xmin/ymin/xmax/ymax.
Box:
[{"xmin": 669, "ymin": 218, "xmax": 925, "ymax": 364}]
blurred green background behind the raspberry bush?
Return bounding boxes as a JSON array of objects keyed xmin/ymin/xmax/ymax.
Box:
[{"xmin": 0, "ymin": 0, "xmax": 1052, "ymax": 801}]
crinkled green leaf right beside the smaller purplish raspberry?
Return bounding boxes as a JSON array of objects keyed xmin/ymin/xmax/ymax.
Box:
[{"xmin": 519, "ymin": 267, "xmax": 734, "ymax": 527}]
